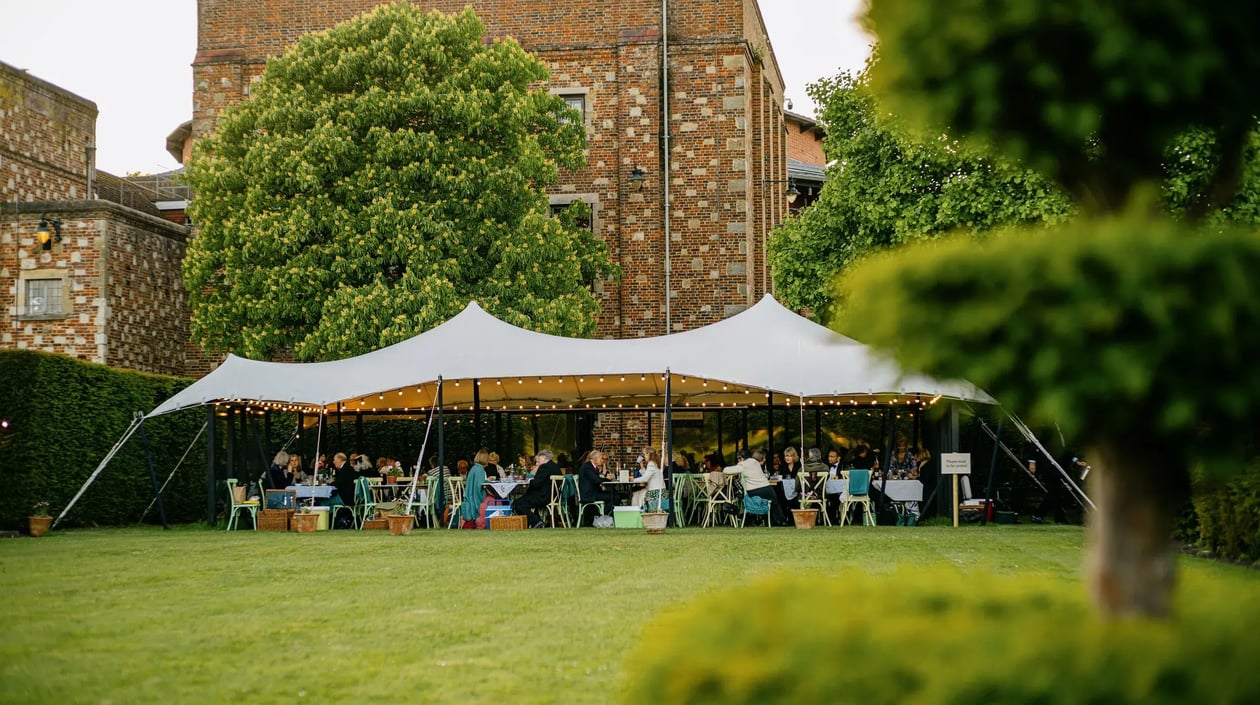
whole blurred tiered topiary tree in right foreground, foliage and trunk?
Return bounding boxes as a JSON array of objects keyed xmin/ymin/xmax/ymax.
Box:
[{"xmin": 845, "ymin": 0, "xmax": 1260, "ymax": 616}]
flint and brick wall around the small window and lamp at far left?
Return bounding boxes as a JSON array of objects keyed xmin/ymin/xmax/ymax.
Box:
[{"xmin": 0, "ymin": 200, "xmax": 201, "ymax": 375}]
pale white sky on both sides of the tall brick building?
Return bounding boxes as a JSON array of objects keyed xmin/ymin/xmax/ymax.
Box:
[{"xmin": 0, "ymin": 0, "xmax": 869, "ymax": 176}]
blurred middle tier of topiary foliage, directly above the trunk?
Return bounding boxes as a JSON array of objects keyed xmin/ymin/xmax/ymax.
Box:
[{"xmin": 844, "ymin": 215, "xmax": 1260, "ymax": 471}]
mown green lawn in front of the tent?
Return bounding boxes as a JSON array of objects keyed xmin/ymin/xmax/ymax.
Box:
[{"xmin": 0, "ymin": 526, "xmax": 1260, "ymax": 705}]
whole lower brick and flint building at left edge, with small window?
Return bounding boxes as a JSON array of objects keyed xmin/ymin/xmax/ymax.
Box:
[{"xmin": 0, "ymin": 63, "xmax": 209, "ymax": 375}]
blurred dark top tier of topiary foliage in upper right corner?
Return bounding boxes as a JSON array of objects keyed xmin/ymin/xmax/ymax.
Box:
[{"xmin": 867, "ymin": 0, "xmax": 1260, "ymax": 210}]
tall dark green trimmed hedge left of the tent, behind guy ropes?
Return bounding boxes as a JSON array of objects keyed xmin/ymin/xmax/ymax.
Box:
[{"xmin": 0, "ymin": 350, "xmax": 205, "ymax": 529}]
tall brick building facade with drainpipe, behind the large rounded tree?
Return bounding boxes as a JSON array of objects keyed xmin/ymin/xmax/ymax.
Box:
[{"xmin": 192, "ymin": 0, "xmax": 789, "ymax": 457}]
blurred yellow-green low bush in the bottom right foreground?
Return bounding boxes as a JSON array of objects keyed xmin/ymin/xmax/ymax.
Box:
[{"xmin": 624, "ymin": 569, "xmax": 1260, "ymax": 705}]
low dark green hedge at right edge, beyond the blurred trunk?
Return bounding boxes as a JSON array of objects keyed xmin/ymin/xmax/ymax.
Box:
[{"xmin": 1194, "ymin": 461, "xmax": 1260, "ymax": 561}]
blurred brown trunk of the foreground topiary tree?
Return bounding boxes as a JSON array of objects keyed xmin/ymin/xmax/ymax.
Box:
[{"xmin": 1087, "ymin": 438, "xmax": 1184, "ymax": 618}]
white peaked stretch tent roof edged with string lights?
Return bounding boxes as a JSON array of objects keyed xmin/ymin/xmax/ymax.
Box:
[{"xmin": 149, "ymin": 295, "xmax": 995, "ymax": 417}]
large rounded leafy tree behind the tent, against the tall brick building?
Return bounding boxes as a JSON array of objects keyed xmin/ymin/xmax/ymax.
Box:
[{"xmin": 184, "ymin": 3, "xmax": 616, "ymax": 360}]
